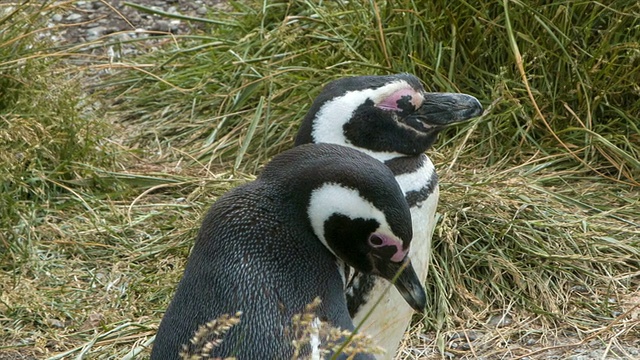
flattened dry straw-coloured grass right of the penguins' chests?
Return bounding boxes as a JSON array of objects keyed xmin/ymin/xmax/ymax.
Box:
[{"xmin": 427, "ymin": 166, "xmax": 640, "ymax": 327}]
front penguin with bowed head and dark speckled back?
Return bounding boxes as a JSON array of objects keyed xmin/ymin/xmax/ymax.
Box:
[{"xmin": 151, "ymin": 144, "xmax": 426, "ymax": 360}]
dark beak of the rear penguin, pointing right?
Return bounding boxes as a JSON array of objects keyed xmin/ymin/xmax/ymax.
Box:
[{"xmin": 417, "ymin": 93, "xmax": 482, "ymax": 126}]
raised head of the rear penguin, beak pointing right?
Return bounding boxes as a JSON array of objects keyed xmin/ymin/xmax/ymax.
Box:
[{"xmin": 296, "ymin": 74, "xmax": 482, "ymax": 161}]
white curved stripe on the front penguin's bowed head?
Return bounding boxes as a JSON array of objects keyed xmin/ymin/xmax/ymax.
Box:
[{"xmin": 307, "ymin": 183, "xmax": 395, "ymax": 255}]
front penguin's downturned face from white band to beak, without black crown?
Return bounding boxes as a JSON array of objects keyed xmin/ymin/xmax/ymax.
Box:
[{"xmin": 307, "ymin": 183, "xmax": 426, "ymax": 312}]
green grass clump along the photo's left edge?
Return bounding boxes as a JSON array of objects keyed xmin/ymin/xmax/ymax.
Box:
[{"xmin": 0, "ymin": 2, "xmax": 114, "ymax": 264}]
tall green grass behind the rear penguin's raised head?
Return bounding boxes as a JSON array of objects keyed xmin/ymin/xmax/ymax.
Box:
[{"xmin": 104, "ymin": 1, "xmax": 640, "ymax": 185}]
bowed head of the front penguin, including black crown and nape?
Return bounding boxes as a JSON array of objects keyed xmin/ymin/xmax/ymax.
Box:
[{"xmin": 258, "ymin": 144, "xmax": 426, "ymax": 311}]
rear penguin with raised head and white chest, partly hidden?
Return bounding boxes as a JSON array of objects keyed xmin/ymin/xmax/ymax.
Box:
[{"xmin": 295, "ymin": 74, "xmax": 482, "ymax": 359}]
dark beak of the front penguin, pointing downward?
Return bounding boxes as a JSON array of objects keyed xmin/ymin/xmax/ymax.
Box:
[{"xmin": 378, "ymin": 257, "xmax": 427, "ymax": 313}]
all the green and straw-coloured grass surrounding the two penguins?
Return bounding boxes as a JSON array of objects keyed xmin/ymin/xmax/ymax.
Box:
[{"xmin": 0, "ymin": 1, "xmax": 640, "ymax": 358}]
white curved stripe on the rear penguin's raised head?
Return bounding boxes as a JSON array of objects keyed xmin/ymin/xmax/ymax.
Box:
[{"xmin": 311, "ymin": 80, "xmax": 412, "ymax": 161}]
